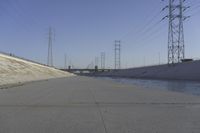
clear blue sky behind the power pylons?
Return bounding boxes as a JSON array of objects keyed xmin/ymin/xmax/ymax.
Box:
[{"xmin": 0, "ymin": 0, "xmax": 200, "ymax": 67}]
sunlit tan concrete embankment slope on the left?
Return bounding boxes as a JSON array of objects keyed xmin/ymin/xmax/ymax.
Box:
[{"xmin": 0, "ymin": 53, "xmax": 72, "ymax": 85}]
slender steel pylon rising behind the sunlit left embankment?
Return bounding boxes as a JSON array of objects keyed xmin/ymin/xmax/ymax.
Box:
[{"xmin": 47, "ymin": 27, "xmax": 53, "ymax": 67}]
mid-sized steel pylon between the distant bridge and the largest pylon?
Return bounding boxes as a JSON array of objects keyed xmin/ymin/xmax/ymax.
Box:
[{"xmin": 115, "ymin": 40, "xmax": 121, "ymax": 69}]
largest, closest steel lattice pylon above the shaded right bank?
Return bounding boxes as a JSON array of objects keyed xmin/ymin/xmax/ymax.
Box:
[{"xmin": 163, "ymin": 0, "xmax": 188, "ymax": 64}]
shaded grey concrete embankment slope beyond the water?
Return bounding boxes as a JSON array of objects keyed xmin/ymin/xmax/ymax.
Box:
[{"xmin": 97, "ymin": 61, "xmax": 200, "ymax": 80}]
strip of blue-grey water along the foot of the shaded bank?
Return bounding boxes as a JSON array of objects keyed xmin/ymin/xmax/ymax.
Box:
[{"xmin": 98, "ymin": 77, "xmax": 200, "ymax": 96}]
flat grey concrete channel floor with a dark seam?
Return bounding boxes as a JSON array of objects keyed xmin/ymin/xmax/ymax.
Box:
[{"xmin": 0, "ymin": 76, "xmax": 200, "ymax": 133}]
